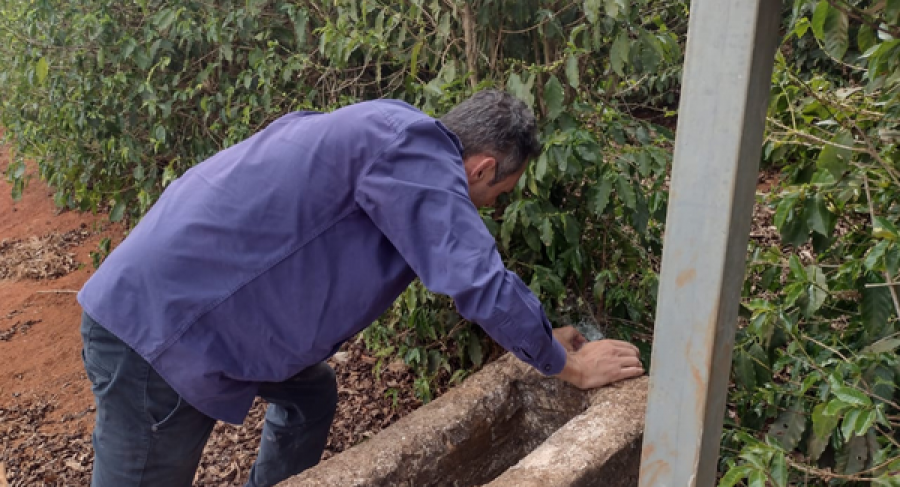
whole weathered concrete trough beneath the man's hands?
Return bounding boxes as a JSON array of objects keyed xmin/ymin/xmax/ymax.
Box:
[{"xmin": 279, "ymin": 354, "xmax": 648, "ymax": 487}]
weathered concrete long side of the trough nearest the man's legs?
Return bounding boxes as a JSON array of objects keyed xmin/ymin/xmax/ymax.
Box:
[{"xmin": 278, "ymin": 354, "xmax": 534, "ymax": 487}]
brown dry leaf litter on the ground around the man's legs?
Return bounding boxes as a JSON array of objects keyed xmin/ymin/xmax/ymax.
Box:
[{"xmin": 0, "ymin": 342, "xmax": 445, "ymax": 487}]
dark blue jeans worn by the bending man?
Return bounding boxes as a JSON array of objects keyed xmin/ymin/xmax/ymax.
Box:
[{"xmin": 81, "ymin": 314, "xmax": 337, "ymax": 487}]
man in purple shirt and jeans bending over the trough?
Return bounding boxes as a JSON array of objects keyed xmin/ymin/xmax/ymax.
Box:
[{"xmin": 78, "ymin": 91, "xmax": 644, "ymax": 487}]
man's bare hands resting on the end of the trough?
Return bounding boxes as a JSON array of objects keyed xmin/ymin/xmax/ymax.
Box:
[{"xmin": 553, "ymin": 327, "xmax": 644, "ymax": 389}]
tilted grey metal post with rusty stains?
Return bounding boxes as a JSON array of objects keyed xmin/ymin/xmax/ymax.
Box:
[{"xmin": 640, "ymin": 0, "xmax": 781, "ymax": 487}]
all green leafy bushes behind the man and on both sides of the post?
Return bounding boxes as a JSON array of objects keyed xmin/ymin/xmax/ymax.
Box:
[{"xmin": 0, "ymin": 0, "xmax": 900, "ymax": 486}]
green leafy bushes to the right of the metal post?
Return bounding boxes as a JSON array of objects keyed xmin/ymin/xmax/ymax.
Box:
[{"xmin": 722, "ymin": 1, "xmax": 900, "ymax": 485}]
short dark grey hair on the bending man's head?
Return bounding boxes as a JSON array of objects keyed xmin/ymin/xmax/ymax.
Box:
[{"xmin": 440, "ymin": 90, "xmax": 541, "ymax": 184}]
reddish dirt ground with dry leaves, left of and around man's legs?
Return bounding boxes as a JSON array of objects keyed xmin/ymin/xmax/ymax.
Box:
[{"xmin": 0, "ymin": 147, "xmax": 432, "ymax": 487}]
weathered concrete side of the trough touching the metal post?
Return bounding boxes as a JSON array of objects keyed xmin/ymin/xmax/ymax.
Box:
[{"xmin": 485, "ymin": 377, "xmax": 649, "ymax": 487}]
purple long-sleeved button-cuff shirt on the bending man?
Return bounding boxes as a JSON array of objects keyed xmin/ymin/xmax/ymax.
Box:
[{"xmin": 78, "ymin": 100, "xmax": 566, "ymax": 423}]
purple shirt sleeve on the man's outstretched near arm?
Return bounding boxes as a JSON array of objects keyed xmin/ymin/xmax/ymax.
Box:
[{"xmin": 356, "ymin": 120, "xmax": 566, "ymax": 375}]
